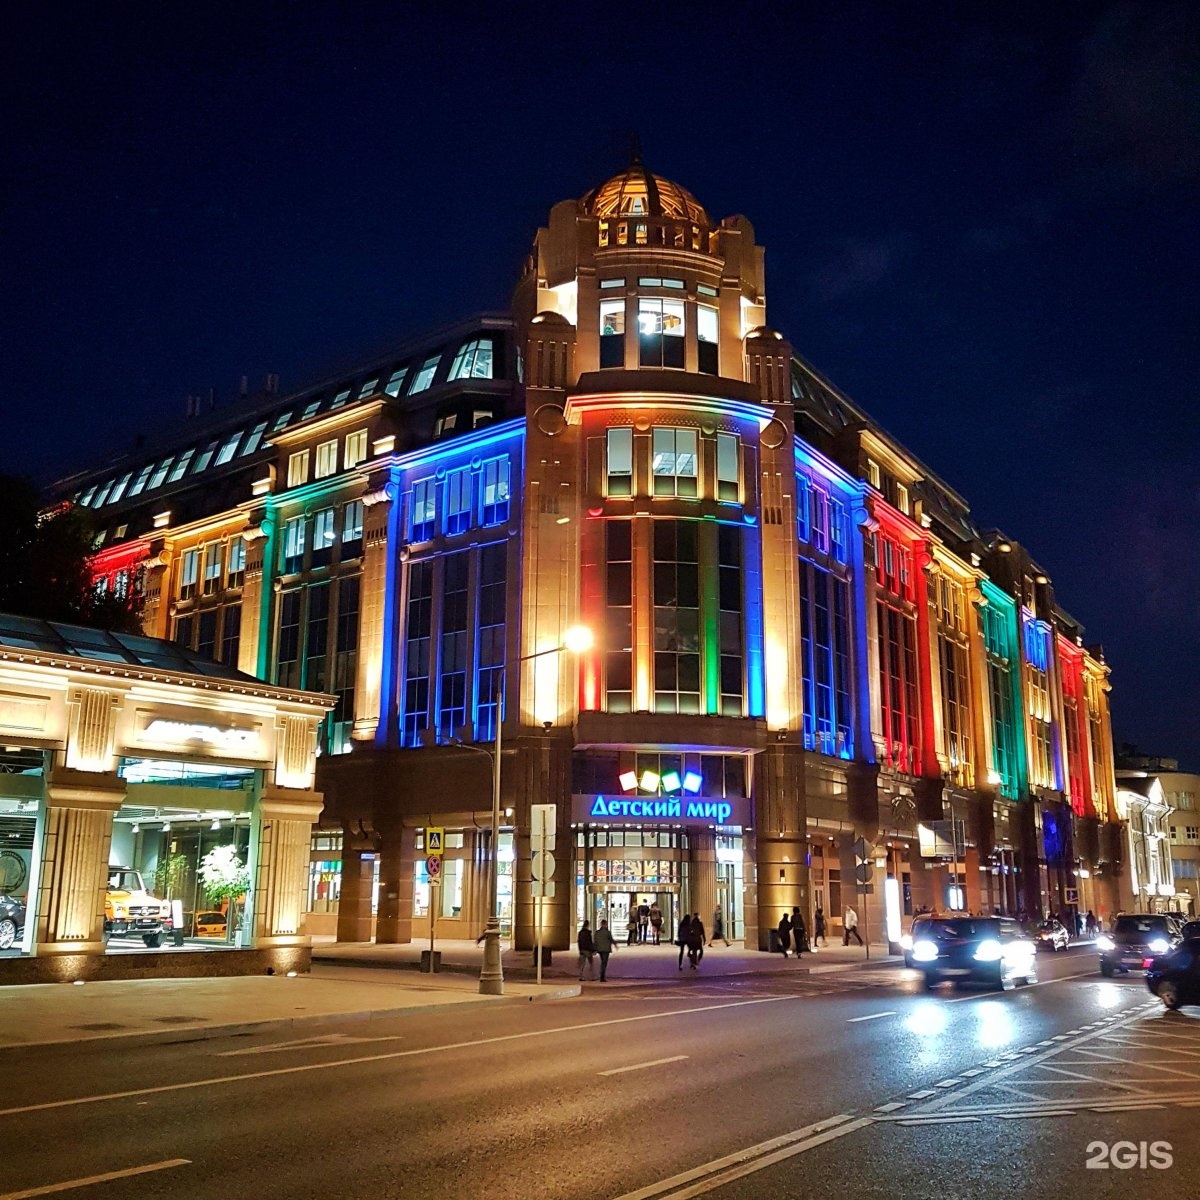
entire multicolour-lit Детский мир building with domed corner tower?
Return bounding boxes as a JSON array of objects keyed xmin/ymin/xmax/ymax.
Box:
[{"xmin": 56, "ymin": 162, "xmax": 1122, "ymax": 949}]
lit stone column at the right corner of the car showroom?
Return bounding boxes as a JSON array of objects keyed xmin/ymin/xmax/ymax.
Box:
[{"xmin": 247, "ymin": 787, "xmax": 323, "ymax": 947}]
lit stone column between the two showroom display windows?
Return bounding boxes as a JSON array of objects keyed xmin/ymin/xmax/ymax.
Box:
[{"xmin": 34, "ymin": 767, "xmax": 125, "ymax": 955}]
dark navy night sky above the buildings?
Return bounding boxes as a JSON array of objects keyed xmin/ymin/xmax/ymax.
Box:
[{"xmin": 0, "ymin": 0, "xmax": 1200, "ymax": 769}]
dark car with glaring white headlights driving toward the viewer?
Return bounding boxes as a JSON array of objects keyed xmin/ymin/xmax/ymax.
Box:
[{"xmin": 912, "ymin": 917, "xmax": 1038, "ymax": 989}]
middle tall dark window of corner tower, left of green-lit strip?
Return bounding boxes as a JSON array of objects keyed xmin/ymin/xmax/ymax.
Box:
[{"xmin": 654, "ymin": 521, "xmax": 701, "ymax": 713}]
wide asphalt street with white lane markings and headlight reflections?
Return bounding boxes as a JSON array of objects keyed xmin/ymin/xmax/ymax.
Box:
[{"xmin": 0, "ymin": 948, "xmax": 1200, "ymax": 1200}]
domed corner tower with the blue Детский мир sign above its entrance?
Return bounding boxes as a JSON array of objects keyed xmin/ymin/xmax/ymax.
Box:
[{"xmin": 514, "ymin": 158, "xmax": 808, "ymax": 944}]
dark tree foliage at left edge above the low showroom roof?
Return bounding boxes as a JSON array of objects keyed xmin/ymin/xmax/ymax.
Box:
[{"xmin": 0, "ymin": 475, "xmax": 140, "ymax": 632}]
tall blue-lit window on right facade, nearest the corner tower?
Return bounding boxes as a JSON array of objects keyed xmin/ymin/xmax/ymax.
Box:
[{"xmin": 800, "ymin": 558, "xmax": 853, "ymax": 758}]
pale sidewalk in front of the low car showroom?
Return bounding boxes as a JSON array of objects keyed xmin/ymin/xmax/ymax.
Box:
[{"xmin": 0, "ymin": 968, "xmax": 580, "ymax": 1050}]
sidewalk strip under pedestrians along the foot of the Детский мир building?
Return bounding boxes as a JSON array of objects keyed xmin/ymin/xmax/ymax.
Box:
[{"xmin": 312, "ymin": 937, "xmax": 904, "ymax": 983}]
